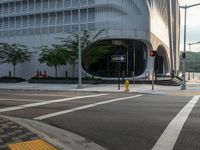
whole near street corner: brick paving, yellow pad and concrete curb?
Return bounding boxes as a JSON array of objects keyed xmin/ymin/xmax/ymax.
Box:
[{"xmin": 0, "ymin": 115, "xmax": 105, "ymax": 150}]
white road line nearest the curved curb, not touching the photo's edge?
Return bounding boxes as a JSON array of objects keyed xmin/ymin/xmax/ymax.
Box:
[{"xmin": 34, "ymin": 95, "xmax": 142, "ymax": 120}]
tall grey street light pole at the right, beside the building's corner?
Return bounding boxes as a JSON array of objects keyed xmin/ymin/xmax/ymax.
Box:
[{"xmin": 181, "ymin": 5, "xmax": 187, "ymax": 90}]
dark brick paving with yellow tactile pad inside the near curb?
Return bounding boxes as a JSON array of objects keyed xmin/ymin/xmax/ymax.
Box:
[{"xmin": 0, "ymin": 116, "xmax": 57, "ymax": 150}]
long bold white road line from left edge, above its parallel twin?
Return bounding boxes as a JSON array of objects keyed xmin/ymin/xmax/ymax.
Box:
[{"xmin": 0, "ymin": 94, "xmax": 107, "ymax": 113}]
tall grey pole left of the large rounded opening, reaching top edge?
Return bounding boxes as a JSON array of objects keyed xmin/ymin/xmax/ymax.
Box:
[{"xmin": 77, "ymin": 0, "xmax": 82, "ymax": 89}]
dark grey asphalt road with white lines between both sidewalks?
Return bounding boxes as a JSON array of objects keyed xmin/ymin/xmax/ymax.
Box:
[{"xmin": 0, "ymin": 91, "xmax": 200, "ymax": 150}]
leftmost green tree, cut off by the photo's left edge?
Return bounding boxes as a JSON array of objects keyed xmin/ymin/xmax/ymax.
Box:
[{"xmin": 0, "ymin": 43, "xmax": 33, "ymax": 77}]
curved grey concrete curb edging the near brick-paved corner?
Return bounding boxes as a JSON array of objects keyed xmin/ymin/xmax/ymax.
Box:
[{"xmin": 0, "ymin": 115, "xmax": 106, "ymax": 150}]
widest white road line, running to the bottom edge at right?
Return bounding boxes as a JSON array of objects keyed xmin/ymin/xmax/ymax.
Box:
[{"xmin": 152, "ymin": 96, "xmax": 200, "ymax": 150}]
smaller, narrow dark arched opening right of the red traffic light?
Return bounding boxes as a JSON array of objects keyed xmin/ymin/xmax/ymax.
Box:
[{"xmin": 154, "ymin": 46, "xmax": 169, "ymax": 74}]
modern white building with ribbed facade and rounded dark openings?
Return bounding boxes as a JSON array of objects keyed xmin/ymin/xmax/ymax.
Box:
[{"xmin": 0, "ymin": 0, "xmax": 180, "ymax": 78}]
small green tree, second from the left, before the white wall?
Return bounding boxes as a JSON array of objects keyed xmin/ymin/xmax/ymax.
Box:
[{"xmin": 38, "ymin": 45, "xmax": 68, "ymax": 78}]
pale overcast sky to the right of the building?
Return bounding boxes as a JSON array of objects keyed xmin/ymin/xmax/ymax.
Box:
[{"xmin": 179, "ymin": 0, "xmax": 200, "ymax": 52}]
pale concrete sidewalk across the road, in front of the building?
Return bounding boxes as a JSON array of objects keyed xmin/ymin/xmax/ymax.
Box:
[{"xmin": 0, "ymin": 82, "xmax": 200, "ymax": 95}]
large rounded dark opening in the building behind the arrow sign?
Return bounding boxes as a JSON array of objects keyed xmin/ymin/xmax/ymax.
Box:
[{"xmin": 83, "ymin": 39, "xmax": 147, "ymax": 78}]
